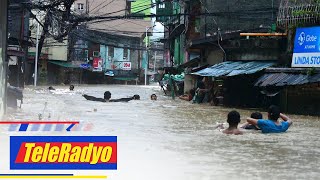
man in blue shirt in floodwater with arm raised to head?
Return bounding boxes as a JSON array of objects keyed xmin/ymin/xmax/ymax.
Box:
[{"xmin": 247, "ymin": 105, "xmax": 292, "ymax": 133}]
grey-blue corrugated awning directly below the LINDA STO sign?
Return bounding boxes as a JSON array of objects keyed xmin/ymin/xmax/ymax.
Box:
[{"xmin": 255, "ymin": 73, "xmax": 320, "ymax": 87}]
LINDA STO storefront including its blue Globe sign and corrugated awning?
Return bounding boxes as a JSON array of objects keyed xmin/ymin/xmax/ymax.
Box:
[{"xmin": 255, "ymin": 26, "xmax": 320, "ymax": 115}]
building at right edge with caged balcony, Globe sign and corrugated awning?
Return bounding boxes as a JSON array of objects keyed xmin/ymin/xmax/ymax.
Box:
[{"xmin": 255, "ymin": 0, "xmax": 320, "ymax": 115}]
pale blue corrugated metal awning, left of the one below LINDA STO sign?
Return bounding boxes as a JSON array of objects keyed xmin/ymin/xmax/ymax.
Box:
[{"xmin": 192, "ymin": 61, "xmax": 275, "ymax": 77}]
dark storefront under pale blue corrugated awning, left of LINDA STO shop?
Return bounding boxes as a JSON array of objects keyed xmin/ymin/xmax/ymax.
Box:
[{"xmin": 191, "ymin": 61, "xmax": 275, "ymax": 107}]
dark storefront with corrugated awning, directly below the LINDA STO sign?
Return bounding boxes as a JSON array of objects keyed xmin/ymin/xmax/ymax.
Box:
[{"xmin": 255, "ymin": 68, "xmax": 320, "ymax": 115}]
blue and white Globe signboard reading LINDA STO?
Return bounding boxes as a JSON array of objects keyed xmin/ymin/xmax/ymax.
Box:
[{"xmin": 291, "ymin": 27, "xmax": 320, "ymax": 67}]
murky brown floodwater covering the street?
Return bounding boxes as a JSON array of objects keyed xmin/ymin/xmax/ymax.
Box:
[{"xmin": 1, "ymin": 85, "xmax": 320, "ymax": 180}]
